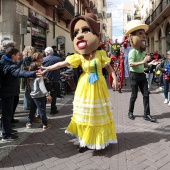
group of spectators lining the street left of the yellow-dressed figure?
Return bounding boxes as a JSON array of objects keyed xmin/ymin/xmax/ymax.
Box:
[{"xmin": 0, "ymin": 39, "xmax": 73, "ymax": 141}]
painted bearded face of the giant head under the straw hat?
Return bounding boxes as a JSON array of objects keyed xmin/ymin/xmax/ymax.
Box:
[{"xmin": 130, "ymin": 30, "xmax": 146, "ymax": 51}]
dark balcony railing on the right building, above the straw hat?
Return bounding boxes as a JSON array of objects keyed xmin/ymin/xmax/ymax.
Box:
[{"xmin": 145, "ymin": 0, "xmax": 170, "ymax": 25}]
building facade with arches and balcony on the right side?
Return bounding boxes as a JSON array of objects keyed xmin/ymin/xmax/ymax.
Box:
[{"xmin": 139, "ymin": 0, "xmax": 170, "ymax": 55}]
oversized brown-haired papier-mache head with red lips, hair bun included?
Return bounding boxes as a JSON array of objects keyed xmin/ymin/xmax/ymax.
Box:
[{"xmin": 70, "ymin": 13, "xmax": 100, "ymax": 55}]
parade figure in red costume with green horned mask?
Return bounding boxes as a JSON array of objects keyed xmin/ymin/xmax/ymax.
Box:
[{"xmin": 109, "ymin": 39, "xmax": 124, "ymax": 93}]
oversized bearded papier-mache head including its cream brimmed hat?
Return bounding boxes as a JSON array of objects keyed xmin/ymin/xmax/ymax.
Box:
[{"xmin": 126, "ymin": 20, "xmax": 149, "ymax": 51}]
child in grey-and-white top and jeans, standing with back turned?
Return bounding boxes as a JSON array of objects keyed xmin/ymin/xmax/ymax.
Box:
[{"xmin": 26, "ymin": 62, "xmax": 52, "ymax": 130}]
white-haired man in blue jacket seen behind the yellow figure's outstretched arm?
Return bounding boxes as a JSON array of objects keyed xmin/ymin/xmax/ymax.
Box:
[{"xmin": 43, "ymin": 47, "xmax": 61, "ymax": 115}]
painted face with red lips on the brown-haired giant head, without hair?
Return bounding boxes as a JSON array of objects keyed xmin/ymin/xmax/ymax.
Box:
[{"xmin": 73, "ymin": 19, "xmax": 99, "ymax": 54}]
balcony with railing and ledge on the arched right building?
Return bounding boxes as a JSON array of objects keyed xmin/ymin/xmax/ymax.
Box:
[{"xmin": 145, "ymin": 0, "xmax": 170, "ymax": 32}]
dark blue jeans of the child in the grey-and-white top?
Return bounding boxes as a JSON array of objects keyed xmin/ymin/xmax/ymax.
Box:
[{"xmin": 28, "ymin": 97, "xmax": 47, "ymax": 126}]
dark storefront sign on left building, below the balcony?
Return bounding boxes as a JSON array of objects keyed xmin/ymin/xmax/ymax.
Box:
[{"xmin": 29, "ymin": 9, "xmax": 49, "ymax": 29}]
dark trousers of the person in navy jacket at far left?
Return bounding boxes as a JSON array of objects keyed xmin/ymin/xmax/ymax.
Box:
[{"xmin": 1, "ymin": 96, "xmax": 14, "ymax": 137}]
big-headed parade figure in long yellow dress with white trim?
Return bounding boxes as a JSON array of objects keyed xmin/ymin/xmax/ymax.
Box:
[{"xmin": 42, "ymin": 13, "xmax": 118, "ymax": 152}]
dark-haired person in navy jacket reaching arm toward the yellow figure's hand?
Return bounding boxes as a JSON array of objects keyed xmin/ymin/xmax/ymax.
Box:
[{"xmin": 0, "ymin": 48, "xmax": 41, "ymax": 141}]
